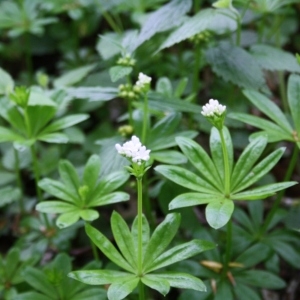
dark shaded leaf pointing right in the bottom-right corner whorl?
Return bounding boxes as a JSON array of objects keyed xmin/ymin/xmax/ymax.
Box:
[{"xmin": 238, "ymin": 270, "xmax": 286, "ymax": 289}]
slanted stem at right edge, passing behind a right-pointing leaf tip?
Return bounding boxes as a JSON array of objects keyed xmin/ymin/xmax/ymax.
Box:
[{"xmin": 260, "ymin": 144, "xmax": 299, "ymax": 236}]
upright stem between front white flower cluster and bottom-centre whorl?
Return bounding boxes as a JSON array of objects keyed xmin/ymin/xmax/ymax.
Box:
[{"xmin": 137, "ymin": 178, "xmax": 143, "ymax": 276}]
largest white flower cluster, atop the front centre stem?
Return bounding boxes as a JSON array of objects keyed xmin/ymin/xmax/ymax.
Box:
[{"xmin": 116, "ymin": 135, "xmax": 151, "ymax": 165}]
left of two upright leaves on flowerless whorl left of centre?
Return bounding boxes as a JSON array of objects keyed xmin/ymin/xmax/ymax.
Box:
[{"xmin": 58, "ymin": 159, "xmax": 80, "ymax": 198}]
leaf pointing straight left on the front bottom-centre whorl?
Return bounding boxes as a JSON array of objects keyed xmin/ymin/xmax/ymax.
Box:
[{"xmin": 68, "ymin": 270, "xmax": 132, "ymax": 285}]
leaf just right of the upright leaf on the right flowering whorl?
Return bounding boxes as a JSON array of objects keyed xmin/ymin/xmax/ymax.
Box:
[{"xmin": 231, "ymin": 136, "xmax": 268, "ymax": 190}]
